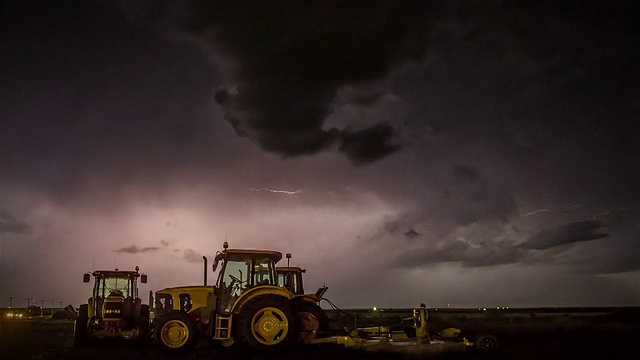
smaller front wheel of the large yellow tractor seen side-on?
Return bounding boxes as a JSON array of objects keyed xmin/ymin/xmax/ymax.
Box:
[{"xmin": 153, "ymin": 311, "xmax": 199, "ymax": 354}]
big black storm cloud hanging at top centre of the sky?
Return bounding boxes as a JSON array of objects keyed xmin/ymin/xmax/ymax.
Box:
[{"xmin": 165, "ymin": 0, "xmax": 436, "ymax": 164}]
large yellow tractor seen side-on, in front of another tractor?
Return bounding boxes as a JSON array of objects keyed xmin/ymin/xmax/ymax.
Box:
[{"xmin": 153, "ymin": 242, "xmax": 300, "ymax": 353}]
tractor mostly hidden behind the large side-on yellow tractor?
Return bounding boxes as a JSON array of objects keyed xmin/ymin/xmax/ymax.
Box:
[{"xmin": 276, "ymin": 253, "xmax": 329, "ymax": 343}]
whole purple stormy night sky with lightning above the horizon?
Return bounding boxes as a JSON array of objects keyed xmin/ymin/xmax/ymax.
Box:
[{"xmin": 0, "ymin": 0, "xmax": 640, "ymax": 308}]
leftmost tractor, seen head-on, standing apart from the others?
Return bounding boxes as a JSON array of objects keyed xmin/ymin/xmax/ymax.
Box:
[{"xmin": 74, "ymin": 266, "xmax": 150, "ymax": 346}]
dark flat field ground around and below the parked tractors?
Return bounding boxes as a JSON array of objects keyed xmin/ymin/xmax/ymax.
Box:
[{"xmin": 0, "ymin": 310, "xmax": 640, "ymax": 360}]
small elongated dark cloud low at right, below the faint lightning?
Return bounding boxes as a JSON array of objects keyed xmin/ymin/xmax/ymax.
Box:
[{"xmin": 522, "ymin": 220, "xmax": 609, "ymax": 250}]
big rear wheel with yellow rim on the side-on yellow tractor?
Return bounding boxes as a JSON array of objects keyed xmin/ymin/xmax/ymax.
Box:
[{"xmin": 235, "ymin": 295, "xmax": 300, "ymax": 352}]
